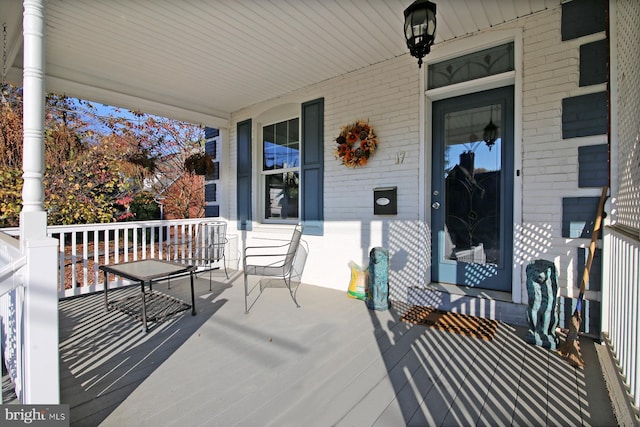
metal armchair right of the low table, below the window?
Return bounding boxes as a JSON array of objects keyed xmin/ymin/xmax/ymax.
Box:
[{"xmin": 242, "ymin": 224, "xmax": 302, "ymax": 313}]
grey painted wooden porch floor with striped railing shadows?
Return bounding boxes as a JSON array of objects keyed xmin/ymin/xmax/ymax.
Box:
[{"xmin": 60, "ymin": 274, "xmax": 616, "ymax": 427}]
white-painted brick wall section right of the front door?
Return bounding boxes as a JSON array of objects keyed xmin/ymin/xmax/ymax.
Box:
[{"xmin": 517, "ymin": 5, "xmax": 607, "ymax": 301}]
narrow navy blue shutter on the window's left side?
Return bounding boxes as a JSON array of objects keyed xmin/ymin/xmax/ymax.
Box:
[{"xmin": 236, "ymin": 119, "xmax": 251, "ymax": 230}]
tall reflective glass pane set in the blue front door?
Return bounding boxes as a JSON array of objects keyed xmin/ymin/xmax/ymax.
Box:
[{"xmin": 442, "ymin": 104, "xmax": 502, "ymax": 264}]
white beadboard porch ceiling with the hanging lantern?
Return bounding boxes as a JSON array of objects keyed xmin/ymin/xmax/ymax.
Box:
[{"xmin": 0, "ymin": 0, "xmax": 561, "ymax": 127}]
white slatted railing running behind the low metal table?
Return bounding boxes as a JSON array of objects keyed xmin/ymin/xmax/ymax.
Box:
[{"xmin": 3, "ymin": 218, "xmax": 237, "ymax": 298}]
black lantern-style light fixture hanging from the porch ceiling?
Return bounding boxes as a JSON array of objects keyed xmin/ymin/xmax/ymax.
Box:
[{"xmin": 404, "ymin": 0, "xmax": 436, "ymax": 68}]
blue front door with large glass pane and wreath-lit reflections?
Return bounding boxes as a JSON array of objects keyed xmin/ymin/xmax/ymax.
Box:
[{"xmin": 431, "ymin": 86, "xmax": 514, "ymax": 292}]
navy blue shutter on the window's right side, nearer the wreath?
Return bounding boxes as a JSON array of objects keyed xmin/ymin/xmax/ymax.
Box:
[{"xmin": 300, "ymin": 98, "xmax": 324, "ymax": 236}]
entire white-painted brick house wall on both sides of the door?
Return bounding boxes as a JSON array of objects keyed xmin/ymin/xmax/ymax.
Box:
[{"xmin": 224, "ymin": 7, "xmax": 606, "ymax": 301}]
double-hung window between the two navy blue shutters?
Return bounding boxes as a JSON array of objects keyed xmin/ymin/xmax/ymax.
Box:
[{"xmin": 261, "ymin": 118, "xmax": 300, "ymax": 222}]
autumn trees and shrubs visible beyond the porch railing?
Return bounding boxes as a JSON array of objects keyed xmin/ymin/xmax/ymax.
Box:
[{"xmin": 0, "ymin": 88, "xmax": 204, "ymax": 227}]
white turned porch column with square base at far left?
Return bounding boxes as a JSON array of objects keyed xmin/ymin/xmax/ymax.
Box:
[{"xmin": 20, "ymin": 0, "xmax": 60, "ymax": 404}]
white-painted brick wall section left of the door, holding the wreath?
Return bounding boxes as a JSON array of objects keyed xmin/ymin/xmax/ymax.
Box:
[{"xmin": 225, "ymin": 55, "xmax": 425, "ymax": 297}]
